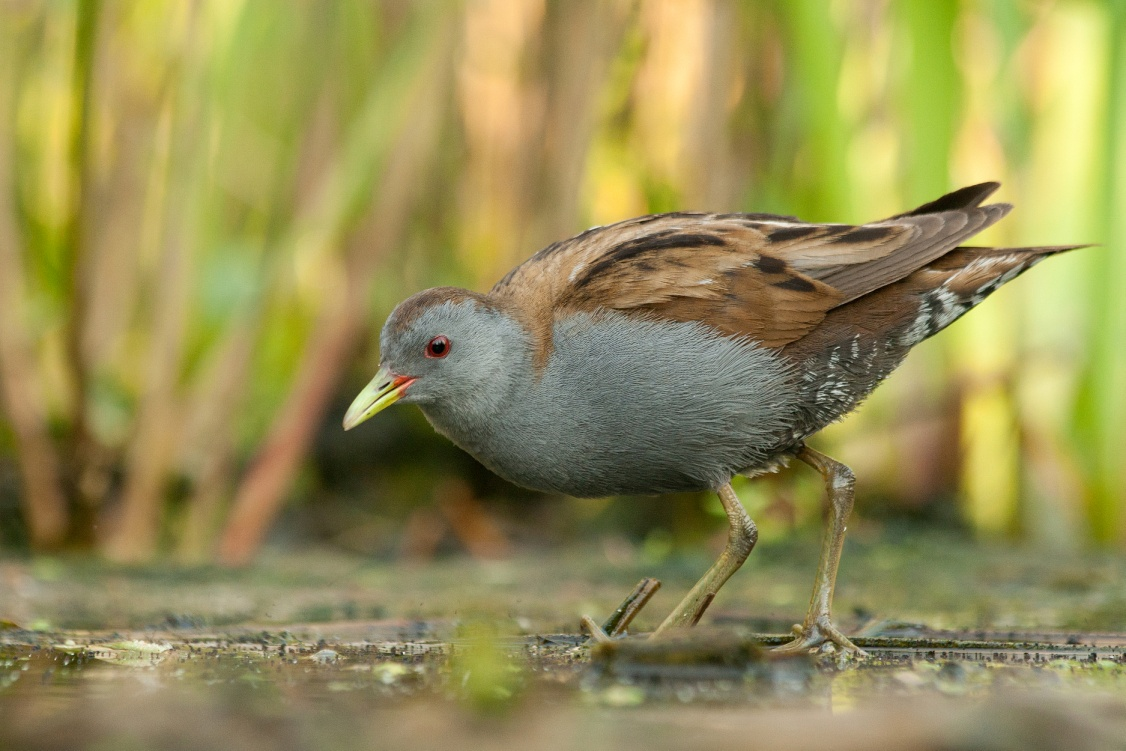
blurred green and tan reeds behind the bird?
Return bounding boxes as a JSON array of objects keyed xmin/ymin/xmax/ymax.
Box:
[{"xmin": 0, "ymin": 0, "xmax": 1126, "ymax": 564}]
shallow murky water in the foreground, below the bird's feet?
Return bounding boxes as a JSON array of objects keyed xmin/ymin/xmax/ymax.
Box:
[{"xmin": 0, "ymin": 623, "xmax": 1126, "ymax": 749}]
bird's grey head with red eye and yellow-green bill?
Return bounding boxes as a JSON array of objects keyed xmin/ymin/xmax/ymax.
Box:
[{"xmin": 343, "ymin": 287, "xmax": 527, "ymax": 430}]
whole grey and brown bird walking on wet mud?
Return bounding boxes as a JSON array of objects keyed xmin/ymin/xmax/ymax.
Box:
[{"xmin": 343, "ymin": 182, "xmax": 1083, "ymax": 652}]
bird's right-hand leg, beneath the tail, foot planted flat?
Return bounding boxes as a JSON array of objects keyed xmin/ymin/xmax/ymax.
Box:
[{"xmin": 777, "ymin": 446, "xmax": 865, "ymax": 655}]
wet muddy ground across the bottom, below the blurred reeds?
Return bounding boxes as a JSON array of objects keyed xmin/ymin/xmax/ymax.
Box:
[{"xmin": 0, "ymin": 535, "xmax": 1126, "ymax": 750}]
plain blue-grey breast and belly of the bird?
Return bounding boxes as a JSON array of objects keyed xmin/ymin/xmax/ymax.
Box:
[{"xmin": 459, "ymin": 313, "xmax": 795, "ymax": 497}]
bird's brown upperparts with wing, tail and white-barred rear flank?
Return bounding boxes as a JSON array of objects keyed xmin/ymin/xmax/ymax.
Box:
[{"xmin": 490, "ymin": 182, "xmax": 1082, "ymax": 452}]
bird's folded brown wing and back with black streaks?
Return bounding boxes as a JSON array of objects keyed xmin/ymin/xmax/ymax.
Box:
[{"xmin": 490, "ymin": 184, "xmax": 1009, "ymax": 358}]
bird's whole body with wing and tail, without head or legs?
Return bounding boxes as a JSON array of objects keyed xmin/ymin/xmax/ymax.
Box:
[{"xmin": 428, "ymin": 184, "xmax": 1073, "ymax": 495}]
